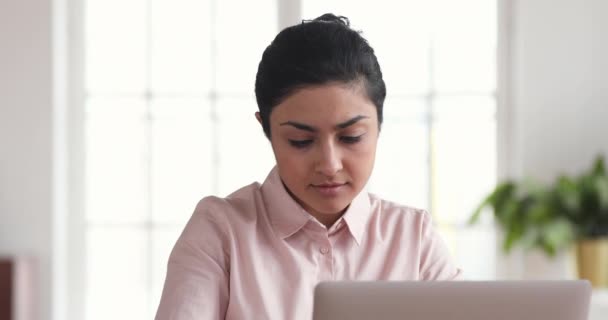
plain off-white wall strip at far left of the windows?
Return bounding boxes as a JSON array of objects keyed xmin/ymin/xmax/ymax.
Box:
[{"xmin": 0, "ymin": 0, "xmax": 53, "ymax": 320}]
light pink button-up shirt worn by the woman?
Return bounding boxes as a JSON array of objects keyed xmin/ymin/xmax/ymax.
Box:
[{"xmin": 156, "ymin": 168, "xmax": 460, "ymax": 320}]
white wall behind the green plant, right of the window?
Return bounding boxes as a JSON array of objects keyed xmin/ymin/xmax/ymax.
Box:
[{"xmin": 499, "ymin": 0, "xmax": 608, "ymax": 278}]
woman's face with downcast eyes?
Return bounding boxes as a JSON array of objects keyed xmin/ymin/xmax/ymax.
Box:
[{"xmin": 260, "ymin": 83, "xmax": 379, "ymax": 225}]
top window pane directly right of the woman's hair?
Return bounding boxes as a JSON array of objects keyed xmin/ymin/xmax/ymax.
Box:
[{"xmin": 302, "ymin": 0, "xmax": 430, "ymax": 95}]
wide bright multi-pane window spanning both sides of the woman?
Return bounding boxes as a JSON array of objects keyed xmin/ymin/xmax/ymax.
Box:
[{"xmin": 78, "ymin": 0, "xmax": 496, "ymax": 320}]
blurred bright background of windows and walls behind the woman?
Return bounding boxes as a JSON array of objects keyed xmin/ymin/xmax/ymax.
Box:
[{"xmin": 0, "ymin": 0, "xmax": 608, "ymax": 320}]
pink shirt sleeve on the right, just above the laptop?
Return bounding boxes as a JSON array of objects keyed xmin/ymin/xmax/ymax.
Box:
[{"xmin": 420, "ymin": 212, "xmax": 462, "ymax": 280}]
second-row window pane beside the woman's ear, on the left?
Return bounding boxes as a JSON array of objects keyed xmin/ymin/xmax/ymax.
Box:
[{"xmin": 217, "ymin": 97, "xmax": 275, "ymax": 196}]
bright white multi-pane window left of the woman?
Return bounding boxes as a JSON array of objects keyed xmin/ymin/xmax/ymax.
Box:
[{"xmin": 85, "ymin": 0, "xmax": 278, "ymax": 320}]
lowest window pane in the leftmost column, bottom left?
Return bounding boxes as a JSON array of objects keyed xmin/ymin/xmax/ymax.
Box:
[{"xmin": 86, "ymin": 227, "xmax": 149, "ymax": 320}]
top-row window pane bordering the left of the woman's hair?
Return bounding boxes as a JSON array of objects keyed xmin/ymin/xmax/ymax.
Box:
[{"xmin": 214, "ymin": 0, "xmax": 278, "ymax": 94}]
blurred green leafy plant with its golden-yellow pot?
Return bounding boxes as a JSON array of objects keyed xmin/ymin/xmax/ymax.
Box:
[{"xmin": 470, "ymin": 157, "xmax": 608, "ymax": 287}]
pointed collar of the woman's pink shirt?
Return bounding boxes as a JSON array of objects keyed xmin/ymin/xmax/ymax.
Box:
[{"xmin": 262, "ymin": 166, "xmax": 371, "ymax": 244}]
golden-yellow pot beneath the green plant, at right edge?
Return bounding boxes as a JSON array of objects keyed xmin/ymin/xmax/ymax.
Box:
[{"xmin": 576, "ymin": 237, "xmax": 608, "ymax": 288}]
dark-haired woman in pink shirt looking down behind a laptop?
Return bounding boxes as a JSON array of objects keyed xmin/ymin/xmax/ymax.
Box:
[{"xmin": 156, "ymin": 14, "xmax": 460, "ymax": 320}]
